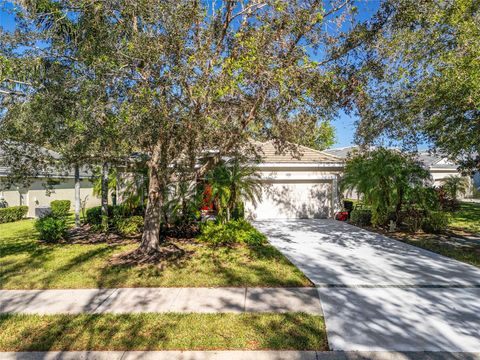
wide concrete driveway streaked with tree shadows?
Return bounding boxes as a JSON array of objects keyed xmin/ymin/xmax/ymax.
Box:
[{"xmin": 255, "ymin": 220, "xmax": 480, "ymax": 352}]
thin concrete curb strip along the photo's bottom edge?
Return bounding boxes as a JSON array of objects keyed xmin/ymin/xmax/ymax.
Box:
[{"xmin": 0, "ymin": 351, "xmax": 480, "ymax": 360}]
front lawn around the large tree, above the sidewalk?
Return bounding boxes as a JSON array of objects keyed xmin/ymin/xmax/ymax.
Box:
[{"xmin": 0, "ymin": 220, "xmax": 312, "ymax": 289}]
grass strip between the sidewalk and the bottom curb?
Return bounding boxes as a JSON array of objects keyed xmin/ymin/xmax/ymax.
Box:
[{"xmin": 0, "ymin": 313, "xmax": 328, "ymax": 351}]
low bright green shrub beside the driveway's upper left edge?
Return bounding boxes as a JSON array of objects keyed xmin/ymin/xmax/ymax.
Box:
[{"xmin": 198, "ymin": 220, "xmax": 267, "ymax": 246}]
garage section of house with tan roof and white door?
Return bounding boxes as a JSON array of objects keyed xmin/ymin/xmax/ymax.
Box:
[{"xmin": 245, "ymin": 142, "xmax": 343, "ymax": 220}]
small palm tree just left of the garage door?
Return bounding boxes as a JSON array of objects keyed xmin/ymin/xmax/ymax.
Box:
[{"xmin": 207, "ymin": 158, "xmax": 262, "ymax": 221}]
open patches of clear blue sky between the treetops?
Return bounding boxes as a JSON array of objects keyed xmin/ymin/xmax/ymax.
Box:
[{"xmin": 0, "ymin": 0, "xmax": 379, "ymax": 147}]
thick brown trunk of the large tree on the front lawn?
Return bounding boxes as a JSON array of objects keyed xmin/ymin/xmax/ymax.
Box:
[{"xmin": 140, "ymin": 161, "xmax": 162, "ymax": 254}]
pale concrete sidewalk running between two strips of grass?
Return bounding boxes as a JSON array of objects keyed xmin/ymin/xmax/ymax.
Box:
[{"xmin": 0, "ymin": 288, "xmax": 322, "ymax": 314}]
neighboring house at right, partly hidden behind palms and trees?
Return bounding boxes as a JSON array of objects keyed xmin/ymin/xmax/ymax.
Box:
[{"xmin": 325, "ymin": 146, "xmax": 472, "ymax": 197}]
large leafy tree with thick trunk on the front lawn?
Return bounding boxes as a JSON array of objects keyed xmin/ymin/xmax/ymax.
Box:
[{"xmin": 2, "ymin": 0, "xmax": 376, "ymax": 257}]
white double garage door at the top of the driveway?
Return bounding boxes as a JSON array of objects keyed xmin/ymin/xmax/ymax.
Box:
[{"xmin": 246, "ymin": 181, "xmax": 332, "ymax": 220}]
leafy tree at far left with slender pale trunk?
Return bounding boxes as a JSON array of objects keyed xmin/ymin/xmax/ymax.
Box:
[{"xmin": 0, "ymin": 1, "xmax": 131, "ymax": 225}]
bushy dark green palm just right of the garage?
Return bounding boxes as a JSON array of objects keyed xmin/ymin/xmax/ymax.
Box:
[{"xmin": 341, "ymin": 148, "xmax": 430, "ymax": 225}]
